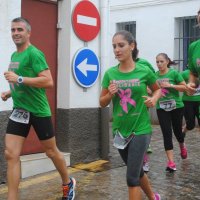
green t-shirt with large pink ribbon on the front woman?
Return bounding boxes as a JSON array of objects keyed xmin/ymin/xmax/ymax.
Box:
[{"xmin": 102, "ymin": 63, "xmax": 156, "ymax": 137}]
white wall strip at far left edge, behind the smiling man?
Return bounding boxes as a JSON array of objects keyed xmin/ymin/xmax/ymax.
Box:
[{"xmin": 0, "ymin": 0, "xmax": 21, "ymax": 111}]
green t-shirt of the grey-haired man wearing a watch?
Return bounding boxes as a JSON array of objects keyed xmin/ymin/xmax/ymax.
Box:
[{"xmin": 9, "ymin": 45, "xmax": 51, "ymax": 117}]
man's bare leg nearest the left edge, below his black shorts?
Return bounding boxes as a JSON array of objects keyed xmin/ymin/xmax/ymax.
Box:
[{"xmin": 5, "ymin": 134, "xmax": 25, "ymax": 200}]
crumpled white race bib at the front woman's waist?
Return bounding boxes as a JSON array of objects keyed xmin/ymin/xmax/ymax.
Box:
[{"xmin": 113, "ymin": 132, "xmax": 134, "ymax": 149}]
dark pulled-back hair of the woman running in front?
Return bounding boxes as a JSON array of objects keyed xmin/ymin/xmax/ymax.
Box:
[{"xmin": 113, "ymin": 30, "xmax": 139, "ymax": 61}]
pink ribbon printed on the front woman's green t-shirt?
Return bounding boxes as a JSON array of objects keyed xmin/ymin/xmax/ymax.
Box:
[{"xmin": 118, "ymin": 88, "xmax": 136, "ymax": 113}]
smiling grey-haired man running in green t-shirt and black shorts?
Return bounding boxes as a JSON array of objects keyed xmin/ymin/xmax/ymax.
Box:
[{"xmin": 1, "ymin": 17, "xmax": 76, "ymax": 200}]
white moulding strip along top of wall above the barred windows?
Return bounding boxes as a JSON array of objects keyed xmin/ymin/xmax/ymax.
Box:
[{"xmin": 110, "ymin": 0, "xmax": 193, "ymax": 11}]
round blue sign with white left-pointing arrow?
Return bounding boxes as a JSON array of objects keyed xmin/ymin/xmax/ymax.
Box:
[{"xmin": 73, "ymin": 48, "xmax": 100, "ymax": 88}]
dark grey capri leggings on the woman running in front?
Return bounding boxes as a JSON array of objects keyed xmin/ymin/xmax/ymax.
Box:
[{"xmin": 119, "ymin": 134, "xmax": 151, "ymax": 187}]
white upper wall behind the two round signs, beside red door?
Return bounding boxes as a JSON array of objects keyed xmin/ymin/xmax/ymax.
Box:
[{"xmin": 57, "ymin": 0, "xmax": 100, "ymax": 109}]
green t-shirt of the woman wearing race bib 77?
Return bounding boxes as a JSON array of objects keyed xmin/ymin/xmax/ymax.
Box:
[{"xmin": 156, "ymin": 69, "xmax": 184, "ymax": 111}]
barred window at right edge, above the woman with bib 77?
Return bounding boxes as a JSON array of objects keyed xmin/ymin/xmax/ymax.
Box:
[{"xmin": 174, "ymin": 16, "xmax": 200, "ymax": 70}]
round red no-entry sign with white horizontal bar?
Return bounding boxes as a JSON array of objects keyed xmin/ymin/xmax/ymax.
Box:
[{"xmin": 72, "ymin": 0, "xmax": 100, "ymax": 42}]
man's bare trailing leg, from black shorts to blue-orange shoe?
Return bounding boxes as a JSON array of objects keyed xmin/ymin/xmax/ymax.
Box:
[{"xmin": 41, "ymin": 137, "xmax": 70, "ymax": 184}]
